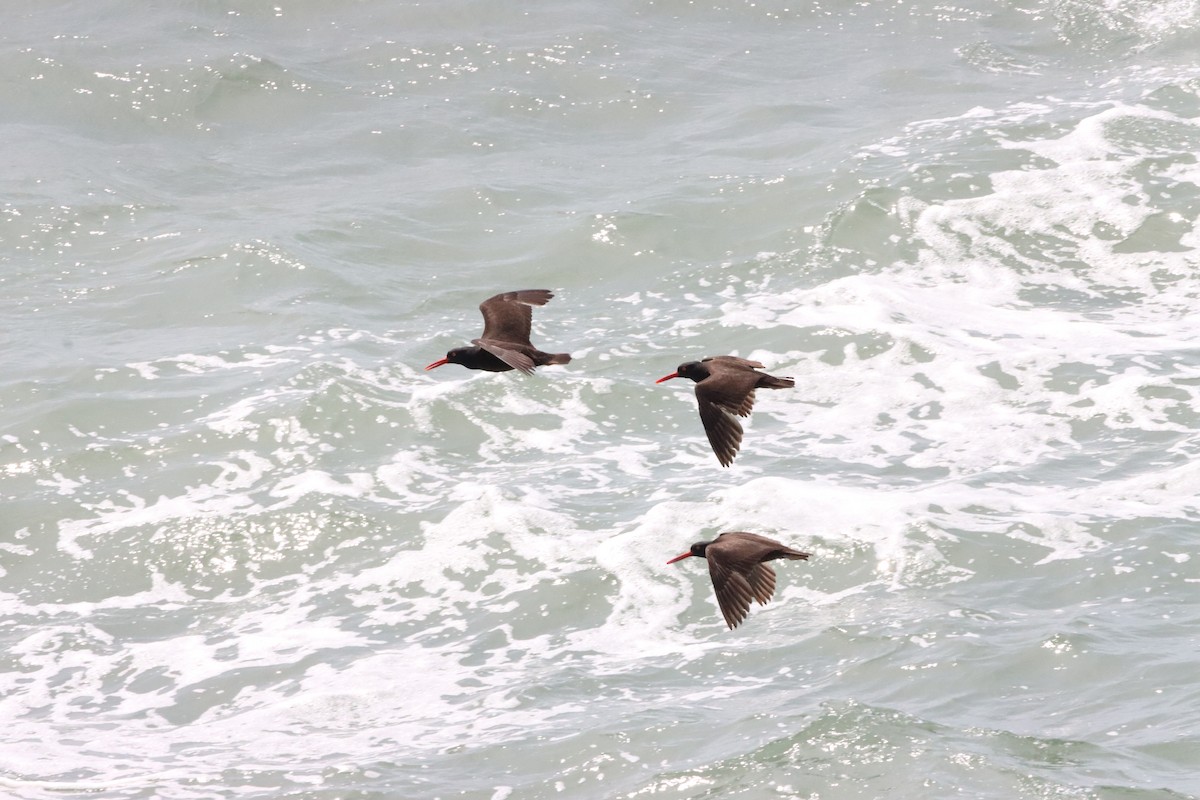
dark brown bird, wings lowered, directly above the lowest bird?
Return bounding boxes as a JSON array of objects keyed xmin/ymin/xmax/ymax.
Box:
[{"xmin": 654, "ymin": 355, "xmax": 796, "ymax": 467}]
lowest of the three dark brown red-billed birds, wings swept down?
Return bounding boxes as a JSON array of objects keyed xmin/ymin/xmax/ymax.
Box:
[{"xmin": 667, "ymin": 530, "xmax": 809, "ymax": 630}]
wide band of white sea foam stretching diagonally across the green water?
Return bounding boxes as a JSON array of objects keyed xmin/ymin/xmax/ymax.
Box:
[{"xmin": 7, "ymin": 62, "xmax": 1200, "ymax": 796}]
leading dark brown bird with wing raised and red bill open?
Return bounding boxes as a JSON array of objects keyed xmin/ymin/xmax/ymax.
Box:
[{"xmin": 425, "ymin": 289, "xmax": 571, "ymax": 375}]
